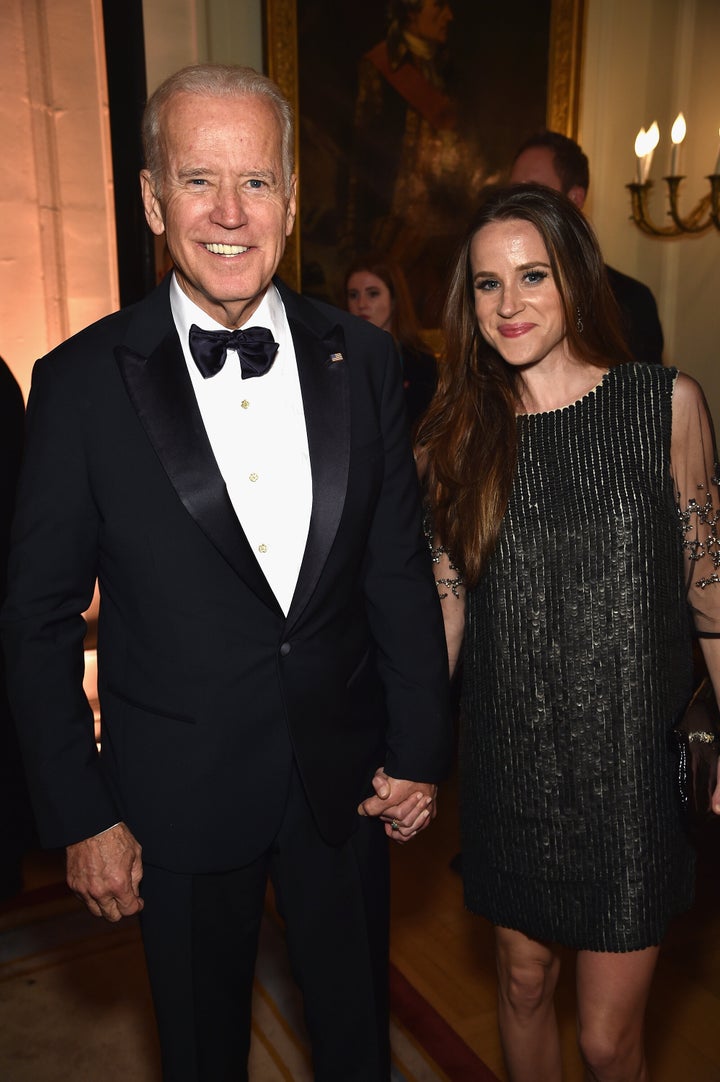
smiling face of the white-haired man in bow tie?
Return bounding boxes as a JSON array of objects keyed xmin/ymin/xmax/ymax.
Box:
[{"xmin": 141, "ymin": 93, "xmax": 296, "ymax": 328}]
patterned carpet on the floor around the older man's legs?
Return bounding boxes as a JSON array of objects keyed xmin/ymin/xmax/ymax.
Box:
[{"xmin": 0, "ymin": 887, "xmax": 495, "ymax": 1082}]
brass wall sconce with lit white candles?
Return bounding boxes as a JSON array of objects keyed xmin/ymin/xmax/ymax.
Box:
[{"xmin": 627, "ymin": 113, "xmax": 720, "ymax": 237}]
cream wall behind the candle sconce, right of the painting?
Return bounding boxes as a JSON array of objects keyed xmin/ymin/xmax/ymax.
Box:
[{"xmin": 580, "ymin": 0, "xmax": 720, "ymax": 425}]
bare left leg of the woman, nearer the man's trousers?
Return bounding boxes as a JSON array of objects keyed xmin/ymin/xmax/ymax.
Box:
[{"xmin": 495, "ymin": 928, "xmax": 562, "ymax": 1082}]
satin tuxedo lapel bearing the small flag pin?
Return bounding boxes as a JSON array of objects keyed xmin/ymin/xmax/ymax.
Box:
[{"xmin": 284, "ymin": 305, "xmax": 350, "ymax": 629}]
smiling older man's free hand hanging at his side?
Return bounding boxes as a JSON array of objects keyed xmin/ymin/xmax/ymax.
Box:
[{"xmin": 67, "ymin": 822, "xmax": 144, "ymax": 923}]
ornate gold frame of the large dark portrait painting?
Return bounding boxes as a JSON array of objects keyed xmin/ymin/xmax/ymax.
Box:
[{"xmin": 263, "ymin": 0, "xmax": 585, "ymax": 290}]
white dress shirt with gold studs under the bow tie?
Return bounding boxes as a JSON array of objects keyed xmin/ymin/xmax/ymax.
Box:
[{"xmin": 170, "ymin": 276, "xmax": 313, "ymax": 616}]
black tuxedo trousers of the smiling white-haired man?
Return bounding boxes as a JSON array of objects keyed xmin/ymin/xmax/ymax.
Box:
[{"xmin": 141, "ymin": 771, "xmax": 390, "ymax": 1082}]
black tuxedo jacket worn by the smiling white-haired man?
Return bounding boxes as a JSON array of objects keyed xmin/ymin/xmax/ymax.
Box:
[{"xmin": 2, "ymin": 279, "xmax": 451, "ymax": 872}]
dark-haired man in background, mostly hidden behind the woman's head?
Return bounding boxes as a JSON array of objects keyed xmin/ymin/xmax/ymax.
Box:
[{"xmin": 510, "ymin": 131, "xmax": 664, "ymax": 365}]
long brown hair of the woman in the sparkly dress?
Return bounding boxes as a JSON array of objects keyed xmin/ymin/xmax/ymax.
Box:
[{"xmin": 417, "ymin": 184, "xmax": 631, "ymax": 586}]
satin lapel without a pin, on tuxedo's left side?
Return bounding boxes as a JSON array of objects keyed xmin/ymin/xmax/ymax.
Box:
[{"xmin": 115, "ymin": 326, "xmax": 282, "ymax": 613}]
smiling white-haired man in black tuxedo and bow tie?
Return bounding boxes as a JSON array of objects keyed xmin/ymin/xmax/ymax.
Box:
[{"xmin": 2, "ymin": 65, "xmax": 451, "ymax": 1082}]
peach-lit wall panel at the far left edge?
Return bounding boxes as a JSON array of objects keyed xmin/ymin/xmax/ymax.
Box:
[{"xmin": 0, "ymin": 0, "xmax": 118, "ymax": 393}]
